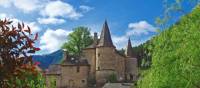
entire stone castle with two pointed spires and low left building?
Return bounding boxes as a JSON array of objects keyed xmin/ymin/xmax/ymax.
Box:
[{"xmin": 45, "ymin": 21, "xmax": 138, "ymax": 88}]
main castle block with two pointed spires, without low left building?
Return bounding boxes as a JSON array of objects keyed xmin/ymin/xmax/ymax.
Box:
[{"xmin": 83, "ymin": 21, "xmax": 137, "ymax": 84}]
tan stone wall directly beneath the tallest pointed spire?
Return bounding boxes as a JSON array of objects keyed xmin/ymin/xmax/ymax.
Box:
[{"xmin": 96, "ymin": 47, "xmax": 125, "ymax": 84}]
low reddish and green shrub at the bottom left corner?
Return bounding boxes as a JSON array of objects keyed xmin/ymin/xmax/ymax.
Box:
[{"xmin": 7, "ymin": 62, "xmax": 45, "ymax": 88}]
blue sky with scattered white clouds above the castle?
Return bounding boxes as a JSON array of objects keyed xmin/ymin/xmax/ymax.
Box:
[{"xmin": 0, "ymin": 0, "xmax": 196, "ymax": 54}]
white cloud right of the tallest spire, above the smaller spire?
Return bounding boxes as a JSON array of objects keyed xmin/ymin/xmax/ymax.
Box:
[{"xmin": 127, "ymin": 21, "xmax": 157, "ymax": 35}]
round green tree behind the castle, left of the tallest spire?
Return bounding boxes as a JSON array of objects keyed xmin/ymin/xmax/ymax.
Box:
[{"xmin": 62, "ymin": 27, "xmax": 93, "ymax": 56}]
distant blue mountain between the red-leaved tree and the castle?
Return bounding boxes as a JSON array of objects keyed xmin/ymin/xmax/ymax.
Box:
[{"xmin": 33, "ymin": 50, "xmax": 63, "ymax": 69}]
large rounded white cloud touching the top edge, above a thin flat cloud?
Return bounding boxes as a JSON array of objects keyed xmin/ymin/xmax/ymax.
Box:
[{"xmin": 41, "ymin": 1, "xmax": 83, "ymax": 20}]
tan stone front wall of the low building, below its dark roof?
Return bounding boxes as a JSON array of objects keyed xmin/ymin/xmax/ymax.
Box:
[{"xmin": 61, "ymin": 65, "xmax": 89, "ymax": 88}]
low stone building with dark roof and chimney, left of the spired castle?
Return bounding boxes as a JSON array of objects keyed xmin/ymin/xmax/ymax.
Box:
[{"xmin": 46, "ymin": 54, "xmax": 90, "ymax": 88}]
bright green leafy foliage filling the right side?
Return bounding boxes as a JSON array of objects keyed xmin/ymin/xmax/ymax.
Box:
[{"xmin": 138, "ymin": 6, "xmax": 200, "ymax": 88}]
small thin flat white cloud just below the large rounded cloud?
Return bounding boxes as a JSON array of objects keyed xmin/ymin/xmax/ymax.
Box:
[{"xmin": 37, "ymin": 17, "xmax": 65, "ymax": 24}]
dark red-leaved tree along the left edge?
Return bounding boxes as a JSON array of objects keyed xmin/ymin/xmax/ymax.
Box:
[{"xmin": 0, "ymin": 19, "xmax": 43, "ymax": 88}]
